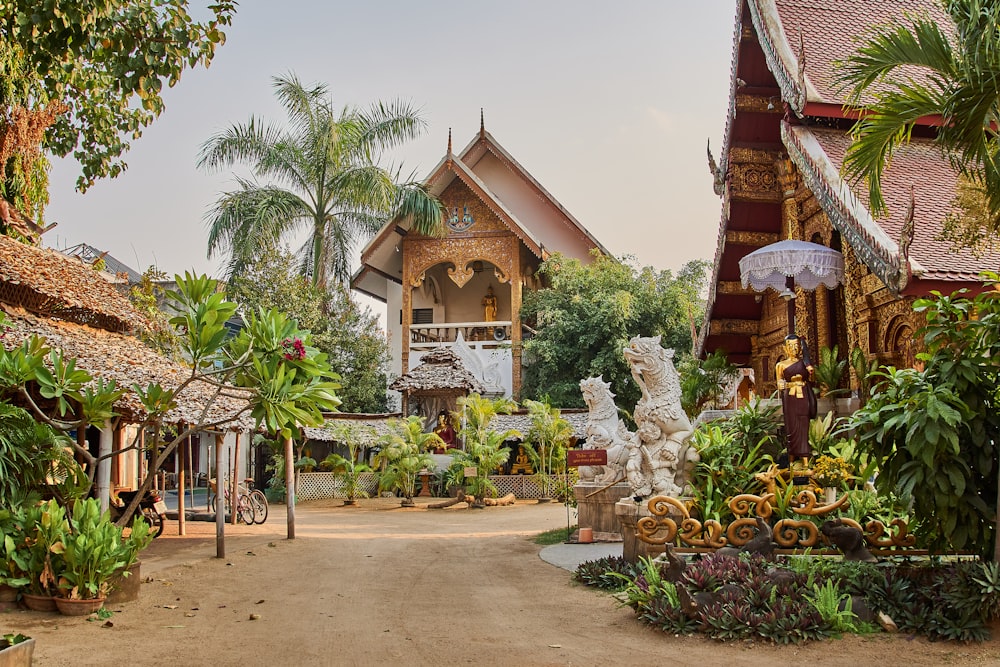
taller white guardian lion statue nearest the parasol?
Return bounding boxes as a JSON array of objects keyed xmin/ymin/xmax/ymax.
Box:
[{"xmin": 623, "ymin": 336, "xmax": 699, "ymax": 498}]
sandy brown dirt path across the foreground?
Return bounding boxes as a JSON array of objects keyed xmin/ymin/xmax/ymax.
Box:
[{"xmin": 7, "ymin": 500, "xmax": 1000, "ymax": 667}]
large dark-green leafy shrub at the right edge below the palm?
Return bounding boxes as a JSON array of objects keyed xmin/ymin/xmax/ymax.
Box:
[{"xmin": 852, "ymin": 292, "xmax": 1000, "ymax": 557}]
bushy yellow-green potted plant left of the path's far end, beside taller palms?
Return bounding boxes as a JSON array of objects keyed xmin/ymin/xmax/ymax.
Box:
[{"xmin": 375, "ymin": 416, "xmax": 441, "ymax": 507}]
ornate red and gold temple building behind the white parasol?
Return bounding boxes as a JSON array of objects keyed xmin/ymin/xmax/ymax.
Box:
[{"xmin": 698, "ymin": 0, "xmax": 1000, "ymax": 396}]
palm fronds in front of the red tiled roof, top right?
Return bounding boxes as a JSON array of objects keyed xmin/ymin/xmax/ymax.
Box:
[{"xmin": 839, "ymin": 0, "xmax": 1000, "ymax": 236}]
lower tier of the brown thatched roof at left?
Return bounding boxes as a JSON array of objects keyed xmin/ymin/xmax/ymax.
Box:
[{"xmin": 2, "ymin": 310, "xmax": 254, "ymax": 431}]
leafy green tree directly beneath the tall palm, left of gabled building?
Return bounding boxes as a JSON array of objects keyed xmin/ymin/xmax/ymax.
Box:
[{"xmin": 226, "ymin": 249, "xmax": 389, "ymax": 413}]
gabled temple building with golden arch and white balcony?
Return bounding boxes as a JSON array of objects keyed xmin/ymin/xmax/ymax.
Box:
[{"xmin": 351, "ymin": 121, "xmax": 606, "ymax": 408}]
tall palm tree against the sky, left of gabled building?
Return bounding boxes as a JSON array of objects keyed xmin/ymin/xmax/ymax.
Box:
[{"xmin": 198, "ymin": 75, "xmax": 442, "ymax": 287}]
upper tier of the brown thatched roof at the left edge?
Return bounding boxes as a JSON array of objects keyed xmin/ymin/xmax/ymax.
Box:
[{"xmin": 0, "ymin": 235, "xmax": 146, "ymax": 332}]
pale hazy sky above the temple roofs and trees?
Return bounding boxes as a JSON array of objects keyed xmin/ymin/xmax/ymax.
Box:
[{"xmin": 44, "ymin": 0, "xmax": 736, "ymax": 288}]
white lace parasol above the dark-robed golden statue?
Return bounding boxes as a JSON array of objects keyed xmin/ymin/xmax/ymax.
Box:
[{"xmin": 740, "ymin": 240, "xmax": 844, "ymax": 292}]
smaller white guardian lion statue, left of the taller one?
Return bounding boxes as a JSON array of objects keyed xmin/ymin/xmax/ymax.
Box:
[{"xmin": 579, "ymin": 376, "xmax": 632, "ymax": 485}]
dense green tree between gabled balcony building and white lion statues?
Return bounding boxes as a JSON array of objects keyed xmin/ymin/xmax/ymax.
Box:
[{"xmin": 521, "ymin": 253, "xmax": 708, "ymax": 407}]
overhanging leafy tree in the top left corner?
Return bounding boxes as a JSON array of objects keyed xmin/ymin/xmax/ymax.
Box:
[{"xmin": 0, "ymin": 0, "xmax": 236, "ymax": 215}]
